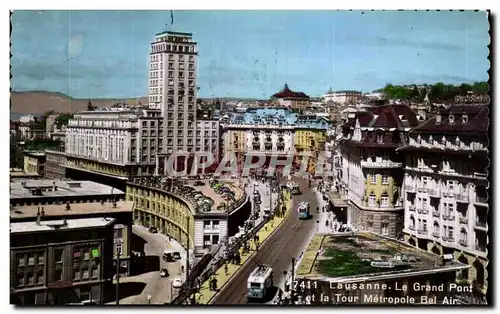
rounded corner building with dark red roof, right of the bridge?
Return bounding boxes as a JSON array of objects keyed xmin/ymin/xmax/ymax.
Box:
[{"xmin": 337, "ymin": 105, "xmax": 418, "ymax": 237}]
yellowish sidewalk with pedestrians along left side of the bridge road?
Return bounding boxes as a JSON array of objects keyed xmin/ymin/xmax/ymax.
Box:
[{"xmin": 192, "ymin": 192, "xmax": 291, "ymax": 304}]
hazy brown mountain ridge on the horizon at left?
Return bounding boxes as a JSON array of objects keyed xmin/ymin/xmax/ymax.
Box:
[{"xmin": 10, "ymin": 91, "xmax": 266, "ymax": 115}]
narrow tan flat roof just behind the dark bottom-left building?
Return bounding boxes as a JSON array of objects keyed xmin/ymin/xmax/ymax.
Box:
[{"xmin": 10, "ymin": 201, "xmax": 133, "ymax": 220}]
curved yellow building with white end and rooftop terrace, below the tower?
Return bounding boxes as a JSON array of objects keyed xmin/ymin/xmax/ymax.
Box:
[{"xmin": 127, "ymin": 178, "xmax": 251, "ymax": 256}]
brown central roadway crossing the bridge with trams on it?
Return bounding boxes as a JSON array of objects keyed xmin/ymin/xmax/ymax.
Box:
[{"xmin": 213, "ymin": 179, "xmax": 317, "ymax": 304}]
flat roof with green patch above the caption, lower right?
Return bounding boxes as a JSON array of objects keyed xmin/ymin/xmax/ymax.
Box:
[{"xmin": 297, "ymin": 232, "xmax": 469, "ymax": 282}]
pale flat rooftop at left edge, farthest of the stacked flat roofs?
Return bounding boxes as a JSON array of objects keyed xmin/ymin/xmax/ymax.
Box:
[{"xmin": 10, "ymin": 177, "xmax": 125, "ymax": 199}]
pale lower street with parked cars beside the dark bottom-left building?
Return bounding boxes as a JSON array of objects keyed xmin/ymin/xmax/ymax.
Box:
[{"xmin": 113, "ymin": 225, "xmax": 186, "ymax": 304}]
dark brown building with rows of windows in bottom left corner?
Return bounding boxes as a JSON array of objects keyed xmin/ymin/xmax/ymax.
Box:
[{"xmin": 10, "ymin": 217, "xmax": 115, "ymax": 305}]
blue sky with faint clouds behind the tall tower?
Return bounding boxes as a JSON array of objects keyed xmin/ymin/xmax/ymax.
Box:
[{"xmin": 11, "ymin": 11, "xmax": 490, "ymax": 99}]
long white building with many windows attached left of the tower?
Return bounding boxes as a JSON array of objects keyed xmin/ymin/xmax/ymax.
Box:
[{"xmin": 65, "ymin": 107, "xmax": 163, "ymax": 179}]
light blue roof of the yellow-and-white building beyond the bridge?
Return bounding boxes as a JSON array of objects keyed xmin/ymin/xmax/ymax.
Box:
[{"xmin": 230, "ymin": 108, "xmax": 330, "ymax": 130}]
